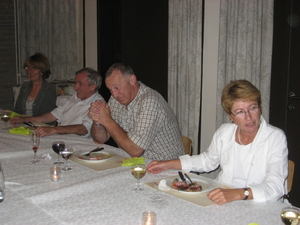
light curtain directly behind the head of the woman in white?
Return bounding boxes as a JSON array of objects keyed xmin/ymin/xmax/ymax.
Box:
[{"xmin": 217, "ymin": 0, "xmax": 273, "ymax": 127}]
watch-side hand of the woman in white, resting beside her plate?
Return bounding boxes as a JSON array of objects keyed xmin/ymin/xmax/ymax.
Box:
[{"xmin": 207, "ymin": 188, "xmax": 243, "ymax": 205}]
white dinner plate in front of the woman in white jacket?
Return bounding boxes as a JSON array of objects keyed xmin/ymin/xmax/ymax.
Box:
[{"xmin": 166, "ymin": 176, "xmax": 216, "ymax": 194}]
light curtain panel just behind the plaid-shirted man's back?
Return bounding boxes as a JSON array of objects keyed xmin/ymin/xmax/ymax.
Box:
[{"xmin": 168, "ymin": 0, "xmax": 202, "ymax": 154}]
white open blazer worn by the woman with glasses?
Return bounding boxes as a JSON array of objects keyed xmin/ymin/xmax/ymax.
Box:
[{"xmin": 179, "ymin": 116, "xmax": 288, "ymax": 202}]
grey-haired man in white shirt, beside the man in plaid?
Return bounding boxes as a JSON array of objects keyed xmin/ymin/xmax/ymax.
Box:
[{"xmin": 10, "ymin": 68, "xmax": 105, "ymax": 137}]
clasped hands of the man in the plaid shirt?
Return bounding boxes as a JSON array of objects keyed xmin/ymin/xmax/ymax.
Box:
[{"xmin": 88, "ymin": 100, "xmax": 111, "ymax": 124}]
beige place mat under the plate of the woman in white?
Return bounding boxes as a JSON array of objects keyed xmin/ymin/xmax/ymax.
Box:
[{"xmin": 146, "ymin": 174, "xmax": 230, "ymax": 207}]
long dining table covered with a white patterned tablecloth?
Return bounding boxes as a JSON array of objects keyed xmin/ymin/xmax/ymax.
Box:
[{"xmin": 0, "ymin": 121, "xmax": 287, "ymax": 225}]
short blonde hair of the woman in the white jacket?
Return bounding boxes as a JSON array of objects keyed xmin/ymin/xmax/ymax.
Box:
[{"xmin": 221, "ymin": 80, "xmax": 261, "ymax": 114}]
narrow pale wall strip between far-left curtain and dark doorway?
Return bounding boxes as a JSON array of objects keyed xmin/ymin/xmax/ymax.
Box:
[{"xmin": 85, "ymin": 0, "xmax": 98, "ymax": 70}]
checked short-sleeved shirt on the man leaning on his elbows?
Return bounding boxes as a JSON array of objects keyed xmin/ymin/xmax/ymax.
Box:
[{"xmin": 108, "ymin": 82, "xmax": 184, "ymax": 160}]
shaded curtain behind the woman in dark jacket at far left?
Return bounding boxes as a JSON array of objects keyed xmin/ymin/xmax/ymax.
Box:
[{"xmin": 17, "ymin": 0, "xmax": 83, "ymax": 81}]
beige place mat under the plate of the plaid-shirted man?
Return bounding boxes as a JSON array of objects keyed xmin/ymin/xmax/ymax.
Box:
[{"xmin": 70, "ymin": 153, "xmax": 127, "ymax": 171}]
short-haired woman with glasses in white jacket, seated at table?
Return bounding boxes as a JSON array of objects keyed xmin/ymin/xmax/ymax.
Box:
[{"xmin": 147, "ymin": 80, "xmax": 288, "ymax": 205}]
